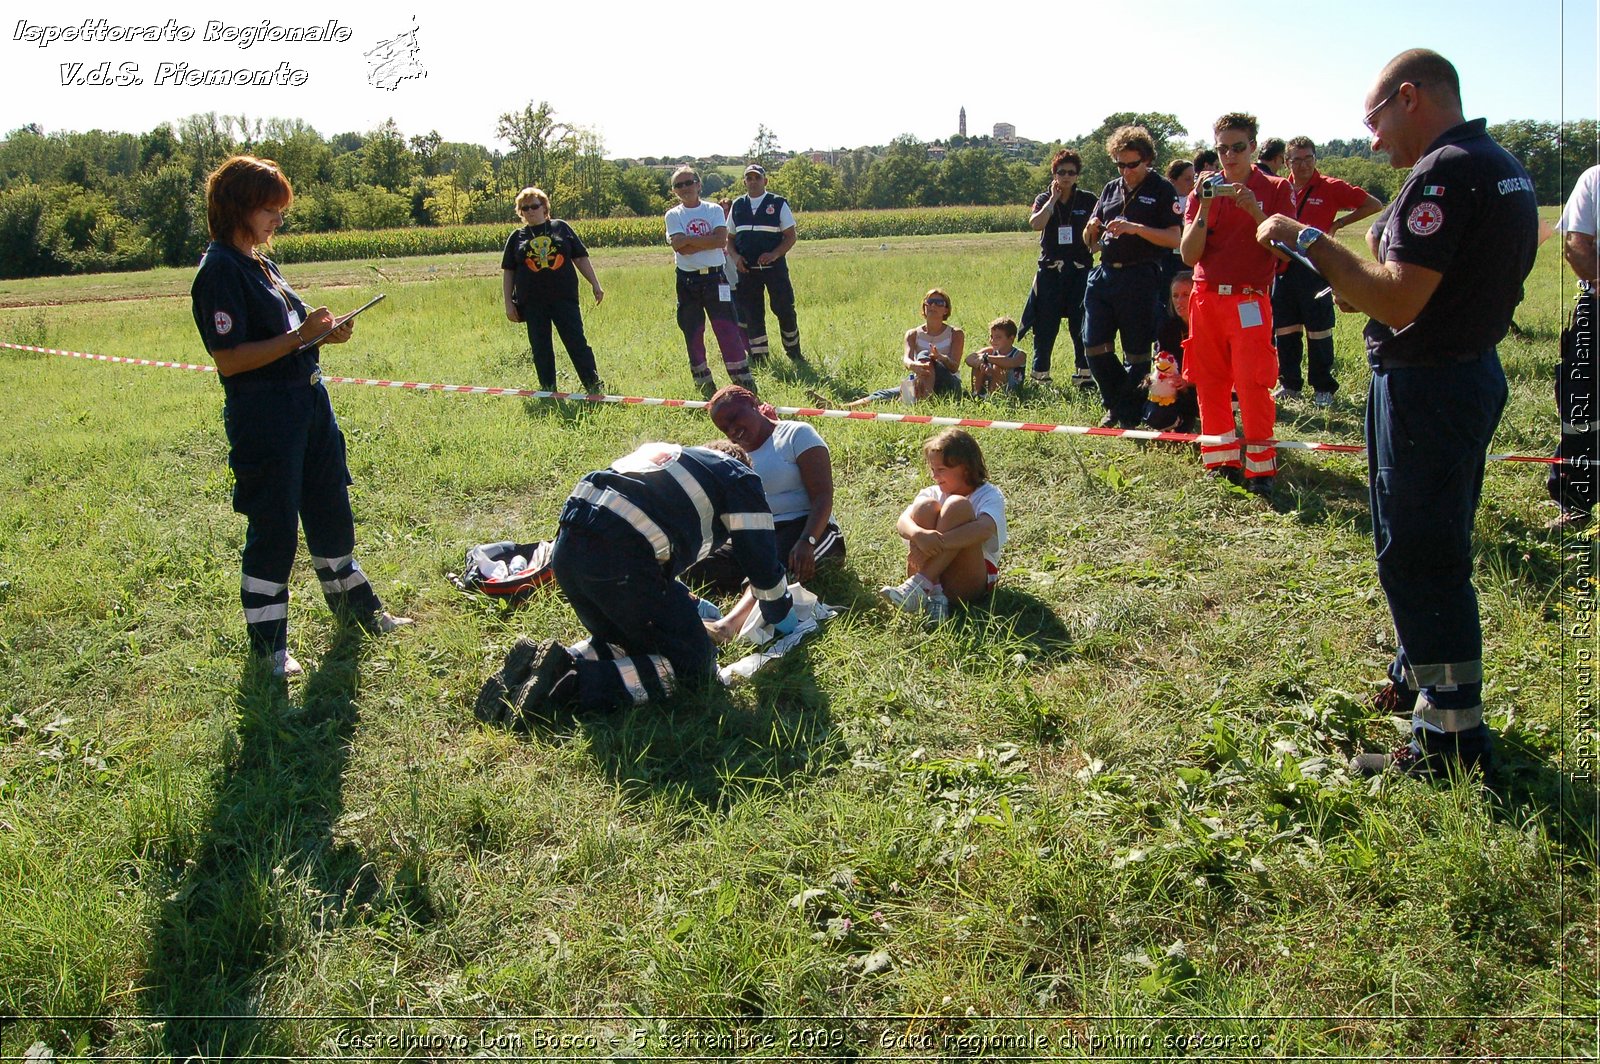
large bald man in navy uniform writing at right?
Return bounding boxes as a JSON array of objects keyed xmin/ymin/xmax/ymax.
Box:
[{"xmin": 1258, "ymin": 48, "xmax": 1538, "ymax": 774}]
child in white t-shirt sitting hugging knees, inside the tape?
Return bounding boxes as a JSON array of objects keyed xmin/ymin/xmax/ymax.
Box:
[{"xmin": 878, "ymin": 429, "xmax": 1006, "ymax": 621}]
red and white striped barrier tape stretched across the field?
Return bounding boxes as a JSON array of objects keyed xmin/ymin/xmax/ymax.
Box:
[{"xmin": 0, "ymin": 341, "xmax": 1562, "ymax": 466}]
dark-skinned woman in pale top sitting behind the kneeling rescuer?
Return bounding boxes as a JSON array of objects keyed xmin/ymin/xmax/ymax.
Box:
[{"xmin": 685, "ymin": 384, "xmax": 845, "ymax": 590}]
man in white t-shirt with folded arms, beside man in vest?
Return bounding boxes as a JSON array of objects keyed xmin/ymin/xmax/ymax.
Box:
[{"xmin": 667, "ymin": 166, "xmax": 755, "ymax": 398}]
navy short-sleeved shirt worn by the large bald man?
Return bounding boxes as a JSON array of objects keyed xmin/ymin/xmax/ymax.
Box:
[{"xmin": 1366, "ymin": 118, "xmax": 1539, "ymax": 366}]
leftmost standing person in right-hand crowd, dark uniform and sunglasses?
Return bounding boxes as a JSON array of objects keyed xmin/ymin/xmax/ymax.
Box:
[{"xmin": 1019, "ymin": 147, "xmax": 1094, "ymax": 387}]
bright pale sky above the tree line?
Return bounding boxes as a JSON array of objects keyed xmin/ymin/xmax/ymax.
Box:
[{"xmin": 0, "ymin": 0, "xmax": 1600, "ymax": 157}]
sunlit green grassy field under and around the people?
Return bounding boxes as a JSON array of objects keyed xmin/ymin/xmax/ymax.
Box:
[{"xmin": 0, "ymin": 228, "xmax": 1600, "ymax": 1059}]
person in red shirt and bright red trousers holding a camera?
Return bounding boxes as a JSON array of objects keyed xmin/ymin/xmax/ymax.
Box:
[{"xmin": 1179, "ymin": 114, "xmax": 1294, "ymax": 494}]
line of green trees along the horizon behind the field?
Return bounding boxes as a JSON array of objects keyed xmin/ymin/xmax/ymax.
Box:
[{"xmin": 0, "ymin": 102, "xmax": 1597, "ymax": 277}]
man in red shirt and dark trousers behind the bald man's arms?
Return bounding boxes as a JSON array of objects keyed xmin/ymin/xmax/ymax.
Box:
[{"xmin": 1272, "ymin": 136, "xmax": 1384, "ymax": 406}]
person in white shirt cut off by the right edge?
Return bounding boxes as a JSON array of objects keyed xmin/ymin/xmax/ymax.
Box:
[{"xmin": 1546, "ymin": 166, "xmax": 1600, "ymax": 528}]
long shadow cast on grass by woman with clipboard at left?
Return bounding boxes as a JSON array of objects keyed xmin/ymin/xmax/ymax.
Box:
[{"xmin": 141, "ymin": 629, "xmax": 370, "ymax": 1059}]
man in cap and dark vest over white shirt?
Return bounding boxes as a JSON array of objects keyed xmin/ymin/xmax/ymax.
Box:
[{"xmin": 728, "ymin": 163, "xmax": 805, "ymax": 362}]
